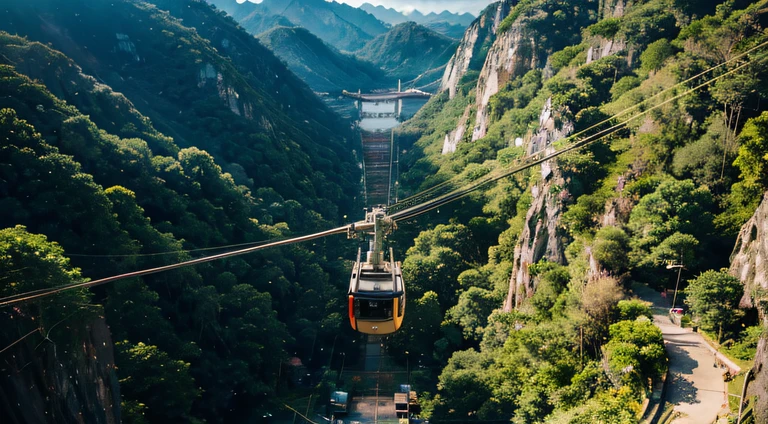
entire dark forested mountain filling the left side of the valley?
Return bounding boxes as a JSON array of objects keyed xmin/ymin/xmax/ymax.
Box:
[{"xmin": 0, "ymin": 0, "xmax": 359, "ymax": 423}]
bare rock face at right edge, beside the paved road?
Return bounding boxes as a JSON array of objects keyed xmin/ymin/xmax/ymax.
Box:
[{"xmin": 730, "ymin": 192, "xmax": 768, "ymax": 424}]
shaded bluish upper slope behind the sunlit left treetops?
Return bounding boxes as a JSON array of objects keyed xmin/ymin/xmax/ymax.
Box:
[{"xmin": 0, "ymin": 0, "xmax": 357, "ymax": 219}]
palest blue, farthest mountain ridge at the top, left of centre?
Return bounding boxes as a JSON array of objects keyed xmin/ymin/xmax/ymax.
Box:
[{"xmin": 209, "ymin": 0, "xmax": 387, "ymax": 52}]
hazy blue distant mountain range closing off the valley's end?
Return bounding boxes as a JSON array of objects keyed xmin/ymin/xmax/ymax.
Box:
[{"xmin": 213, "ymin": 0, "xmax": 454, "ymax": 101}]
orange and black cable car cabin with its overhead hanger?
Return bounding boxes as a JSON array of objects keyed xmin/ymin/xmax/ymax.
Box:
[{"xmin": 348, "ymin": 209, "xmax": 405, "ymax": 334}]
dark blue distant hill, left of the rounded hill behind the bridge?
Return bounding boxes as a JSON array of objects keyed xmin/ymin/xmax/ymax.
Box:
[{"xmin": 259, "ymin": 27, "xmax": 384, "ymax": 95}]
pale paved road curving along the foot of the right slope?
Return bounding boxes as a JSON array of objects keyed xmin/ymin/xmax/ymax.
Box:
[{"xmin": 633, "ymin": 286, "xmax": 727, "ymax": 424}]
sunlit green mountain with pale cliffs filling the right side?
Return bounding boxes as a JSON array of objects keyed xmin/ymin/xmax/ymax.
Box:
[{"xmin": 390, "ymin": 0, "xmax": 768, "ymax": 423}]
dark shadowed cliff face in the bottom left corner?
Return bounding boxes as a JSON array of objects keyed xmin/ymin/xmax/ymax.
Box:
[{"xmin": 0, "ymin": 318, "xmax": 120, "ymax": 424}]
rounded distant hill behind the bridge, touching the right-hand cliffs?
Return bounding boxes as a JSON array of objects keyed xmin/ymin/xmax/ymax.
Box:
[{"xmin": 355, "ymin": 22, "xmax": 456, "ymax": 86}]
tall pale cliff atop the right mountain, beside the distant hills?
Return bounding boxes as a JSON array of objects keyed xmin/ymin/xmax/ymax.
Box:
[{"xmin": 440, "ymin": 0, "xmax": 517, "ymax": 99}]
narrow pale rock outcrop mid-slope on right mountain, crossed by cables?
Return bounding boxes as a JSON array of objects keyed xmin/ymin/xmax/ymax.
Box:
[{"xmin": 504, "ymin": 101, "xmax": 572, "ymax": 312}]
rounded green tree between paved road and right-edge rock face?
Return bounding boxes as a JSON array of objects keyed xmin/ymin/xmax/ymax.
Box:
[{"xmin": 685, "ymin": 269, "xmax": 744, "ymax": 342}]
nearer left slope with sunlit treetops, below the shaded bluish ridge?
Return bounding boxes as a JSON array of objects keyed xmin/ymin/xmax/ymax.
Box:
[{"xmin": 0, "ymin": 24, "xmax": 364, "ymax": 423}]
